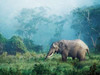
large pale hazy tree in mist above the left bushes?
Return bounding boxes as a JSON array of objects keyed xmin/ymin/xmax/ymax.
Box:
[{"xmin": 16, "ymin": 7, "xmax": 48, "ymax": 40}]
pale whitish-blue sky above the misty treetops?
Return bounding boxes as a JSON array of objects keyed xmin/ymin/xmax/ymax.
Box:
[{"xmin": 0, "ymin": 0, "xmax": 94, "ymax": 31}]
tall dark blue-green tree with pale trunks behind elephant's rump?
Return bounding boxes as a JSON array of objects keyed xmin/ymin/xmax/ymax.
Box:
[{"xmin": 72, "ymin": 5, "xmax": 100, "ymax": 49}]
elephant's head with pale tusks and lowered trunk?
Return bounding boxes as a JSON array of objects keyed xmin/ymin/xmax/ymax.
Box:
[{"xmin": 46, "ymin": 42, "xmax": 65, "ymax": 59}]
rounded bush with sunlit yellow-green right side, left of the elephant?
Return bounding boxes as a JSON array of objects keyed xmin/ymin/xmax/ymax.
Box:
[{"xmin": 6, "ymin": 36, "xmax": 27, "ymax": 54}]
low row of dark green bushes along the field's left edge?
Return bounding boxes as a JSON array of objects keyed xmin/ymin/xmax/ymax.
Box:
[{"xmin": 0, "ymin": 34, "xmax": 43, "ymax": 54}]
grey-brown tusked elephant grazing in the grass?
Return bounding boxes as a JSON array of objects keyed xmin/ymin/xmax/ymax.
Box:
[{"xmin": 45, "ymin": 39, "xmax": 89, "ymax": 61}]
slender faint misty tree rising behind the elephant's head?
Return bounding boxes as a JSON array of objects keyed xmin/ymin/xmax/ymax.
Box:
[{"xmin": 50, "ymin": 15, "xmax": 67, "ymax": 44}]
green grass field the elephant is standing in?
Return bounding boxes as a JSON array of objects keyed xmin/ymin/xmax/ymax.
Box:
[{"xmin": 0, "ymin": 52, "xmax": 100, "ymax": 75}]
